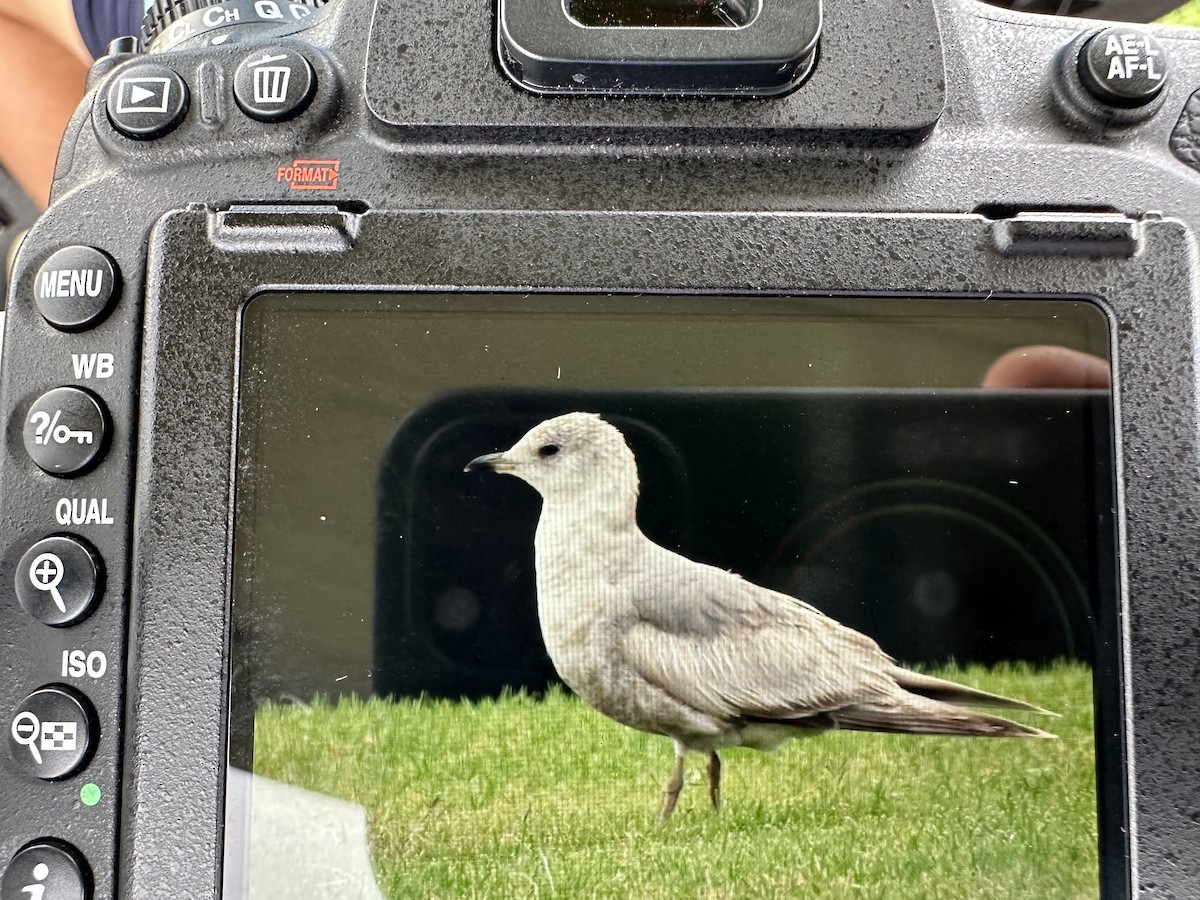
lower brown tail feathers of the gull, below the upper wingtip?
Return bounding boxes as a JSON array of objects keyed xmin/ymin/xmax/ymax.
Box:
[{"xmin": 830, "ymin": 697, "xmax": 1055, "ymax": 738}]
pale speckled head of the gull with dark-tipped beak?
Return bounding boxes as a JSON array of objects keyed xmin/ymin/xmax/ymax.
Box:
[{"xmin": 463, "ymin": 413, "xmax": 637, "ymax": 500}]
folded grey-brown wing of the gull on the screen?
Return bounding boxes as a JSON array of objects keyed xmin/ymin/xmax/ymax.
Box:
[{"xmin": 619, "ymin": 547, "xmax": 896, "ymax": 720}]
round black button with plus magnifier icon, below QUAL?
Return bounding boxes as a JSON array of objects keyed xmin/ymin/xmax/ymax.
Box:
[{"xmin": 16, "ymin": 536, "xmax": 104, "ymax": 628}]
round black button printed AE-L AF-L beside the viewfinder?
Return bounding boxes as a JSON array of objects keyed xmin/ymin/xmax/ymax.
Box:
[{"xmin": 1079, "ymin": 25, "xmax": 1170, "ymax": 109}]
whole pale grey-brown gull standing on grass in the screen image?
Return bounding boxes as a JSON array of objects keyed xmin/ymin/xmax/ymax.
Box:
[{"xmin": 464, "ymin": 413, "xmax": 1054, "ymax": 818}]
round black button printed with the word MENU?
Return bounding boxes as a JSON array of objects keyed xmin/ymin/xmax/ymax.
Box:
[{"xmin": 34, "ymin": 246, "xmax": 120, "ymax": 331}]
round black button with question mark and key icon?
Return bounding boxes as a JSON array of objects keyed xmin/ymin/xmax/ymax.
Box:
[{"xmin": 23, "ymin": 388, "xmax": 110, "ymax": 478}]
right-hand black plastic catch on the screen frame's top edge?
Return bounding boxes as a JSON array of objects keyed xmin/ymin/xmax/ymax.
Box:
[{"xmin": 991, "ymin": 211, "xmax": 1142, "ymax": 259}]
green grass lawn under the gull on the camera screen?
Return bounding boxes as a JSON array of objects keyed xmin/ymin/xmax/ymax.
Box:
[{"xmin": 254, "ymin": 664, "xmax": 1098, "ymax": 900}]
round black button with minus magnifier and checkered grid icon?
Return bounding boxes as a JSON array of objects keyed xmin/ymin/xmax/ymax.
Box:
[{"xmin": 8, "ymin": 686, "xmax": 96, "ymax": 781}]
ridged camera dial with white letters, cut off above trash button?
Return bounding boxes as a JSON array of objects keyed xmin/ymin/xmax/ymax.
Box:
[{"xmin": 142, "ymin": 0, "xmax": 328, "ymax": 53}]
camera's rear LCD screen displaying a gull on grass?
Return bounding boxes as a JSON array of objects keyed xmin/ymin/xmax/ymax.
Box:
[{"xmin": 224, "ymin": 293, "xmax": 1124, "ymax": 899}]
